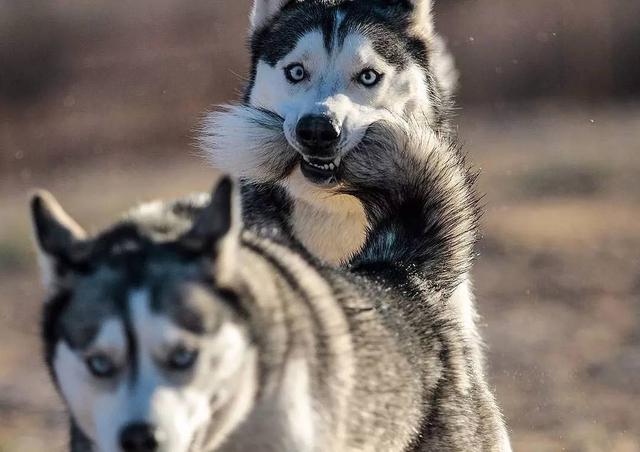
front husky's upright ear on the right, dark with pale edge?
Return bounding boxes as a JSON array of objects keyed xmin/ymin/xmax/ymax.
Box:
[{"xmin": 181, "ymin": 176, "xmax": 242, "ymax": 286}]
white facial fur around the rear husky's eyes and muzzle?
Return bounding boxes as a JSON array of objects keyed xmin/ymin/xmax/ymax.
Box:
[{"xmin": 249, "ymin": 29, "xmax": 431, "ymax": 157}]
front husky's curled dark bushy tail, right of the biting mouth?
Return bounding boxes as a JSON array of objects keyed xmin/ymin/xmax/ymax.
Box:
[{"xmin": 342, "ymin": 122, "xmax": 478, "ymax": 293}]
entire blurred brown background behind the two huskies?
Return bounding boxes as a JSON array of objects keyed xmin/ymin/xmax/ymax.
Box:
[{"xmin": 0, "ymin": 0, "xmax": 640, "ymax": 452}]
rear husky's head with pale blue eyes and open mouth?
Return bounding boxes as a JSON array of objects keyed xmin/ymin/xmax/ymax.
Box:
[{"xmin": 246, "ymin": 0, "xmax": 450, "ymax": 186}]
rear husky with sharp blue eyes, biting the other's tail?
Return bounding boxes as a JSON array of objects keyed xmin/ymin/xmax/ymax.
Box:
[{"xmin": 200, "ymin": 0, "xmax": 479, "ymax": 358}]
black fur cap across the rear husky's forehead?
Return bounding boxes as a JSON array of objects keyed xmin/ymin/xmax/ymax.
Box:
[{"xmin": 243, "ymin": 0, "xmax": 455, "ymax": 136}]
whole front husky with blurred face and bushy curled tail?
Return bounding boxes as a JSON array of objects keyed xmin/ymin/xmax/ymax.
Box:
[{"xmin": 32, "ymin": 122, "xmax": 510, "ymax": 452}]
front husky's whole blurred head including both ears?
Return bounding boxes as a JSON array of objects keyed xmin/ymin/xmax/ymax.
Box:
[{"xmin": 33, "ymin": 180, "xmax": 255, "ymax": 452}]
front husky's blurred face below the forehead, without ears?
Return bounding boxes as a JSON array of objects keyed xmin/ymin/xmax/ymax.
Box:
[{"xmin": 52, "ymin": 282, "xmax": 250, "ymax": 452}]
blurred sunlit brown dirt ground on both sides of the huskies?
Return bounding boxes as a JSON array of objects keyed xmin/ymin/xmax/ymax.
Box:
[{"xmin": 0, "ymin": 107, "xmax": 640, "ymax": 452}]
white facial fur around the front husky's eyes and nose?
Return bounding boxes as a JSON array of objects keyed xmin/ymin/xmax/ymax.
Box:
[{"xmin": 53, "ymin": 289, "xmax": 254, "ymax": 452}]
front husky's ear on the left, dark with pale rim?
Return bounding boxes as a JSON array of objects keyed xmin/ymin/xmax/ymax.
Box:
[{"xmin": 31, "ymin": 191, "xmax": 87, "ymax": 292}]
